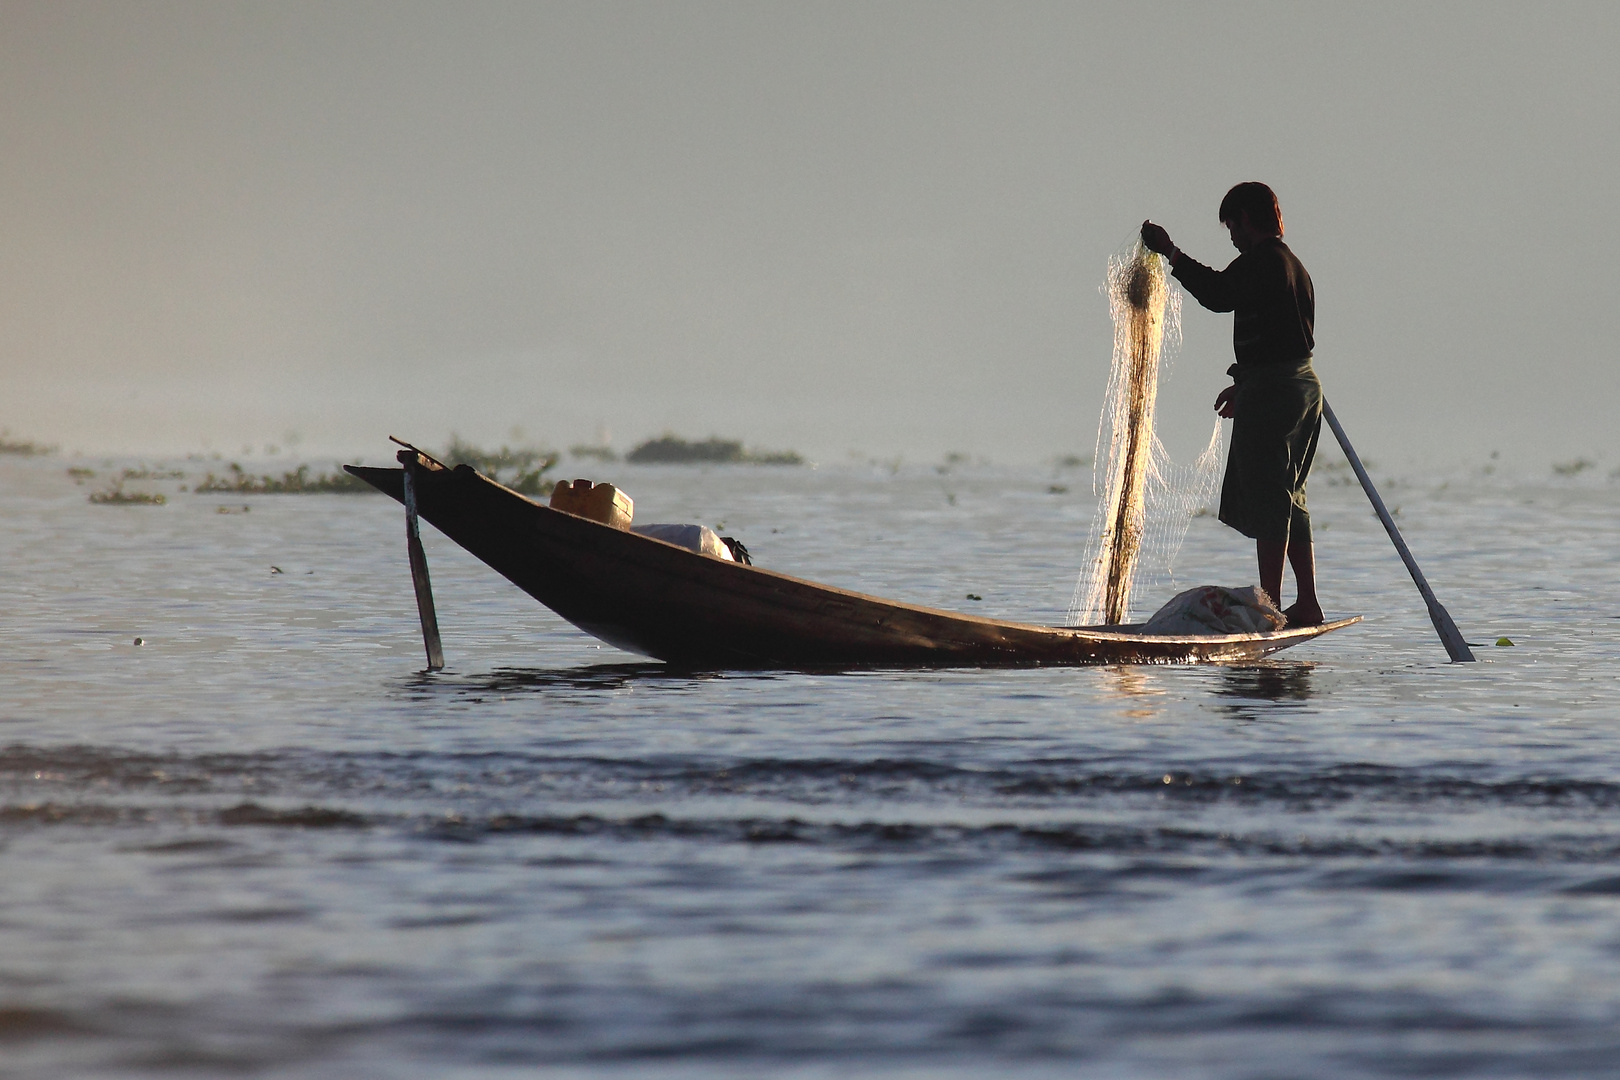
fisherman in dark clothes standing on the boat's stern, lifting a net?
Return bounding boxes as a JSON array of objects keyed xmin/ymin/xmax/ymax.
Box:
[{"xmin": 1142, "ymin": 181, "xmax": 1322, "ymax": 627}]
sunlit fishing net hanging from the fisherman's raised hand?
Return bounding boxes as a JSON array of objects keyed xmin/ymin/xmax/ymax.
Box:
[{"xmin": 1069, "ymin": 240, "xmax": 1221, "ymax": 625}]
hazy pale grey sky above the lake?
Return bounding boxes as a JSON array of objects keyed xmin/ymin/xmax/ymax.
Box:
[{"xmin": 0, "ymin": 0, "xmax": 1620, "ymax": 466}]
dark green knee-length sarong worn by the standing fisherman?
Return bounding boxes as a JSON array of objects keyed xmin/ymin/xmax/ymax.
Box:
[{"xmin": 1220, "ymin": 358, "xmax": 1322, "ymax": 542}]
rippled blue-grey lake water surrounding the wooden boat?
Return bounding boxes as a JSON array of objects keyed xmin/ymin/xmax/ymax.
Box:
[{"xmin": 0, "ymin": 457, "xmax": 1620, "ymax": 1080}]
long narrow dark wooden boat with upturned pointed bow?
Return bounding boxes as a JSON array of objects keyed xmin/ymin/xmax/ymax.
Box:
[{"xmin": 345, "ymin": 453, "xmax": 1359, "ymax": 669}]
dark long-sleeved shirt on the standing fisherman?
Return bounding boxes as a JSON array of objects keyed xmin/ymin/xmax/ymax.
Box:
[{"xmin": 1173, "ymin": 236, "xmax": 1315, "ymax": 368}]
